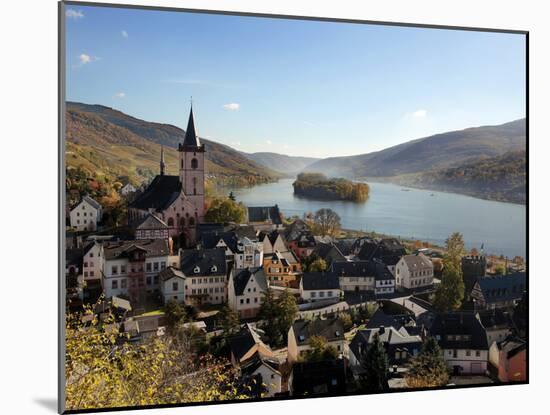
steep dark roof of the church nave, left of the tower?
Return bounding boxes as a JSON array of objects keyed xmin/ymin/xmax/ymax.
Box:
[{"xmin": 129, "ymin": 175, "xmax": 182, "ymax": 212}]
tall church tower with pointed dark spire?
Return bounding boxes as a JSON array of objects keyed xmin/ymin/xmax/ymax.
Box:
[{"xmin": 178, "ymin": 104, "xmax": 204, "ymax": 227}]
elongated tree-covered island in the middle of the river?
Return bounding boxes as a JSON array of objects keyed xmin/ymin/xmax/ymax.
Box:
[{"xmin": 292, "ymin": 173, "xmax": 369, "ymax": 202}]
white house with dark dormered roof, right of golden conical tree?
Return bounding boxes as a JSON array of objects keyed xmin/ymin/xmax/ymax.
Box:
[{"xmin": 430, "ymin": 312, "xmax": 489, "ymax": 375}]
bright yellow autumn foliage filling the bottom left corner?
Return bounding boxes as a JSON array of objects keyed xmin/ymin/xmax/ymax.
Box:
[{"xmin": 65, "ymin": 307, "xmax": 242, "ymax": 410}]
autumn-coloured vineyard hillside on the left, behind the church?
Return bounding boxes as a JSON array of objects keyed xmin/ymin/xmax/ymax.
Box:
[{"xmin": 66, "ymin": 102, "xmax": 281, "ymax": 185}]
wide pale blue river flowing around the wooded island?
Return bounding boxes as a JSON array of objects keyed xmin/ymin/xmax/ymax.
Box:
[{"xmin": 223, "ymin": 179, "xmax": 526, "ymax": 258}]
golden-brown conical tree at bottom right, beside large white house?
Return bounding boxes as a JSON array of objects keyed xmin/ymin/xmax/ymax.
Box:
[{"xmin": 406, "ymin": 337, "xmax": 449, "ymax": 388}]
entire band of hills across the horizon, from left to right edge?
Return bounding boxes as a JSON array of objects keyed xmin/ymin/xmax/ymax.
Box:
[{"xmin": 66, "ymin": 102, "xmax": 526, "ymax": 203}]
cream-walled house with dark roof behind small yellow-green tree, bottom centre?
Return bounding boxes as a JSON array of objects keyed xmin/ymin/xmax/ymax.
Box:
[{"xmin": 288, "ymin": 318, "xmax": 347, "ymax": 363}]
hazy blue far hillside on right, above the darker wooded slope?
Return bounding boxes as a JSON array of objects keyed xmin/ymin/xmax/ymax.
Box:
[{"xmin": 305, "ymin": 119, "xmax": 526, "ymax": 178}]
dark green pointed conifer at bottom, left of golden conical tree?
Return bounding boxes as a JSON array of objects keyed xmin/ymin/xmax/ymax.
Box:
[{"xmin": 360, "ymin": 333, "xmax": 389, "ymax": 392}]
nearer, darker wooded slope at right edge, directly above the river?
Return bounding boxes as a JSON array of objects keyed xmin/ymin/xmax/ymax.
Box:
[{"xmin": 395, "ymin": 150, "xmax": 527, "ymax": 203}]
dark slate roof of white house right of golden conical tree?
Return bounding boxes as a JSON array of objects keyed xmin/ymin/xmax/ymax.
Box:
[{"xmin": 430, "ymin": 312, "xmax": 489, "ymax": 350}]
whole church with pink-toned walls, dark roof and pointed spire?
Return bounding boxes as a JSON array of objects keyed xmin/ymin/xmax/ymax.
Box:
[{"xmin": 128, "ymin": 106, "xmax": 205, "ymax": 247}]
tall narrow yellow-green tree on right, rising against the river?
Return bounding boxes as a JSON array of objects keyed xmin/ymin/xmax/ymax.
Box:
[{"xmin": 434, "ymin": 232, "xmax": 464, "ymax": 312}]
